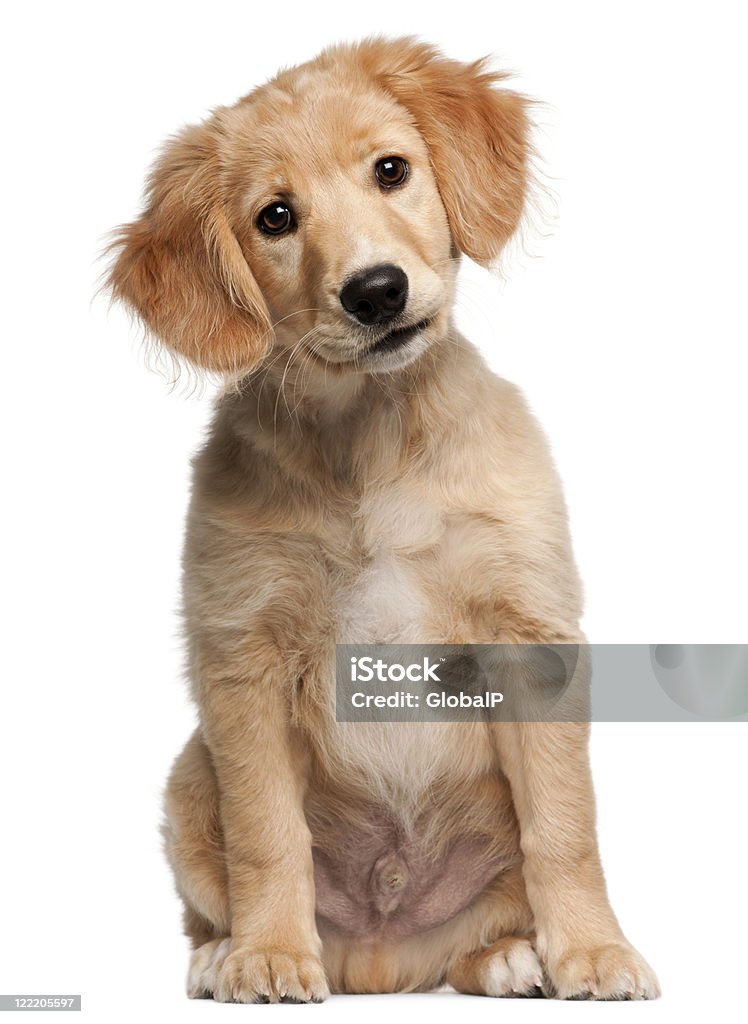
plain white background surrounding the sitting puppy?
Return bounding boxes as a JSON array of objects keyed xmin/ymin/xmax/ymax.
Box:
[{"xmin": 0, "ymin": 0, "xmax": 748, "ymax": 1022}]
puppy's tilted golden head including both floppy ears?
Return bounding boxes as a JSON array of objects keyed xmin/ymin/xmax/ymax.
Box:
[{"xmin": 109, "ymin": 38, "xmax": 528, "ymax": 374}]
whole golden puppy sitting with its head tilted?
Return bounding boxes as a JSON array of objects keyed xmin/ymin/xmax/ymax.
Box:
[{"xmin": 110, "ymin": 38, "xmax": 658, "ymax": 1002}]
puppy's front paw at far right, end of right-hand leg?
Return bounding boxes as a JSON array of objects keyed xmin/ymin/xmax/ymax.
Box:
[{"xmin": 548, "ymin": 942, "xmax": 660, "ymax": 999}]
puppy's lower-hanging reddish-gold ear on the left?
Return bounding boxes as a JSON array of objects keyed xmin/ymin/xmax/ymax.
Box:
[{"xmin": 108, "ymin": 122, "xmax": 272, "ymax": 373}]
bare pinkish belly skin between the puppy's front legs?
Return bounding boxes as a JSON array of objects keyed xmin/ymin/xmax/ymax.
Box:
[{"xmin": 313, "ymin": 820, "xmax": 517, "ymax": 942}]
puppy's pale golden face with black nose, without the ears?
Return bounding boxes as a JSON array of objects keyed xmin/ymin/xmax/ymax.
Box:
[{"xmin": 226, "ymin": 76, "xmax": 448, "ymax": 372}]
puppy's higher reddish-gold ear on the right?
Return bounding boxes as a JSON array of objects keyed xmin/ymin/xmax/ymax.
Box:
[{"xmin": 358, "ymin": 37, "xmax": 530, "ymax": 265}]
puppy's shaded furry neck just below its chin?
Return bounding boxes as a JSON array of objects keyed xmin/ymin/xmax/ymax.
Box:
[{"xmin": 221, "ymin": 323, "xmax": 480, "ymax": 485}]
